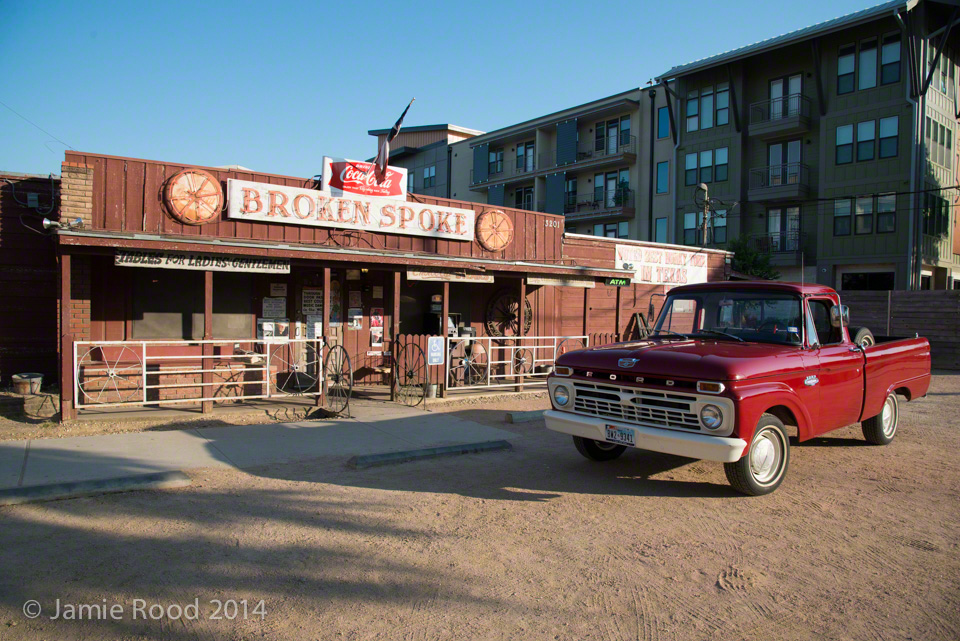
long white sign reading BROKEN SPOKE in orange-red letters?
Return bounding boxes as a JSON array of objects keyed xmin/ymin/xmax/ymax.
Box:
[{"xmin": 227, "ymin": 179, "xmax": 476, "ymax": 241}]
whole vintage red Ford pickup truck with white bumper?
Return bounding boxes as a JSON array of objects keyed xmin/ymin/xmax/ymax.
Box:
[{"xmin": 545, "ymin": 282, "xmax": 930, "ymax": 495}]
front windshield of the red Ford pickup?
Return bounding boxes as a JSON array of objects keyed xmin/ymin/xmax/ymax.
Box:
[{"xmin": 653, "ymin": 291, "xmax": 803, "ymax": 345}]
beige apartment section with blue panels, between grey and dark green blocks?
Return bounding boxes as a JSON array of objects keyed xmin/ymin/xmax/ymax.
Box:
[{"xmin": 450, "ymin": 86, "xmax": 675, "ymax": 242}]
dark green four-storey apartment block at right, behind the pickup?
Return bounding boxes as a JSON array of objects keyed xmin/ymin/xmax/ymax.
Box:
[{"xmin": 657, "ymin": 0, "xmax": 960, "ymax": 290}]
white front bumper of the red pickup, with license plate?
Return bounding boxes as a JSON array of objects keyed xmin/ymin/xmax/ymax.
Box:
[{"xmin": 543, "ymin": 410, "xmax": 747, "ymax": 463}]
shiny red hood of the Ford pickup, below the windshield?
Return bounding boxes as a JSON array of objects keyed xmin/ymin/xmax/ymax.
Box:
[{"xmin": 557, "ymin": 338, "xmax": 803, "ymax": 381}]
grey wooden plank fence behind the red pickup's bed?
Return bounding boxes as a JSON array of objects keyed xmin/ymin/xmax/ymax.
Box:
[{"xmin": 840, "ymin": 290, "xmax": 960, "ymax": 369}]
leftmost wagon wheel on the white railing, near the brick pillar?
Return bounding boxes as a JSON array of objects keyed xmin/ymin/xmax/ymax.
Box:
[{"xmin": 77, "ymin": 345, "xmax": 143, "ymax": 403}]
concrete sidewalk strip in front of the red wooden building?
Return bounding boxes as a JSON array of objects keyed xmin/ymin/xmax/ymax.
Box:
[{"xmin": 0, "ymin": 401, "xmax": 516, "ymax": 489}]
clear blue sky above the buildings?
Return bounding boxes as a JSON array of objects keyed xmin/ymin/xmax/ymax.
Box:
[{"xmin": 0, "ymin": 0, "xmax": 877, "ymax": 177}]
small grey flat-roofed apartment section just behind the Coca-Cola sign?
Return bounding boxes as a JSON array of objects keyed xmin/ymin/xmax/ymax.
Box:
[{"xmin": 367, "ymin": 124, "xmax": 483, "ymax": 198}]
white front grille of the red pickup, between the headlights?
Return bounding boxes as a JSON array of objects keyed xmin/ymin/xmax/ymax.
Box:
[{"xmin": 573, "ymin": 381, "xmax": 700, "ymax": 431}]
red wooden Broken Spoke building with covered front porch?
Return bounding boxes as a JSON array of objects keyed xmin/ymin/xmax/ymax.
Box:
[{"xmin": 50, "ymin": 151, "xmax": 728, "ymax": 419}]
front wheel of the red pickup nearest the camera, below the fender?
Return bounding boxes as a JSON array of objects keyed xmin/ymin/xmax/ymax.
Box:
[{"xmin": 723, "ymin": 414, "xmax": 790, "ymax": 496}]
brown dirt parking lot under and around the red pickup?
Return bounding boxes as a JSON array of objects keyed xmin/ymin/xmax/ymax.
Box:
[{"xmin": 0, "ymin": 375, "xmax": 960, "ymax": 641}]
